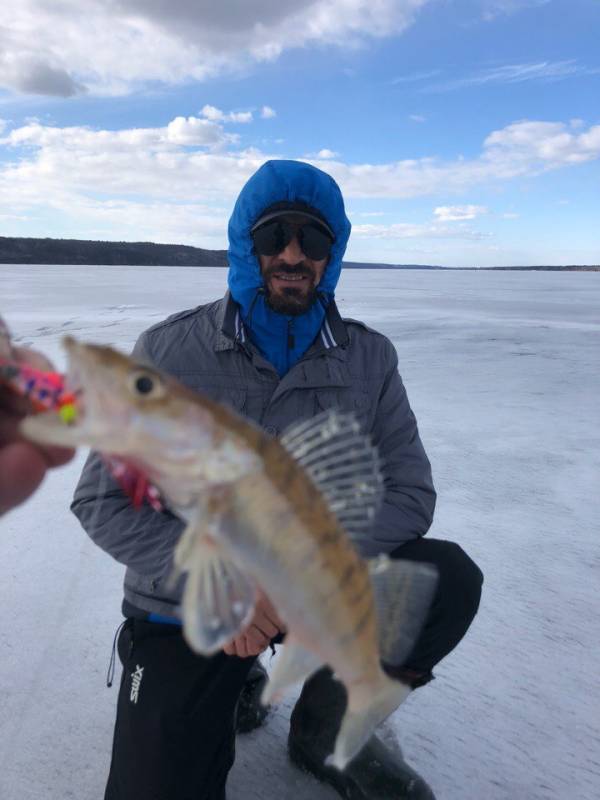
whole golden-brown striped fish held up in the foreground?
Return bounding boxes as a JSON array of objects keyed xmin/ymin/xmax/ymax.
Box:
[{"xmin": 23, "ymin": 337, "xmax": 436, "ymax": 769}]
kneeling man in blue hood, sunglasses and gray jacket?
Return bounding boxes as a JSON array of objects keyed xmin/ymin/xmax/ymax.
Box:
[{"xmin": 72, "ymin": 161, "xmax": 483, "ymax": 800}]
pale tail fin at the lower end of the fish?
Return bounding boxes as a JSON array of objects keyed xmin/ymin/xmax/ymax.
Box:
[{"xmin": 325, "ymin": 672, "xmax": 411, "ymax": 770}]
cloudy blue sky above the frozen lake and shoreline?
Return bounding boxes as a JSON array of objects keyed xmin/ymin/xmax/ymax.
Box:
[{"xmin": 0, "ymin": 0, "xmax": 600, "ymax": 266}]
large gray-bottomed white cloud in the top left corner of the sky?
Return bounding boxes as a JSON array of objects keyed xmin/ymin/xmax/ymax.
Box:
[{"xmin": 0, "ymin": 0, "xmax": 431, "ymax": 97}]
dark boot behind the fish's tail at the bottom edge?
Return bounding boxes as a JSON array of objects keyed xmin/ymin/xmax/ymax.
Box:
[{"xmin": 288, "ymin": 668, "xmax": 435, "ymax": 800}]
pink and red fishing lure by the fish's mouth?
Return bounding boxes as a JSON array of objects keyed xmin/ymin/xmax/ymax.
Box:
[{"xmin": 0, "ymin": 317, "xmax": 164, "ymax": 511}]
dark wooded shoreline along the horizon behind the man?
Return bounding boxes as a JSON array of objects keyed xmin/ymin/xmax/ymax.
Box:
[{"xmin": 0, "ymin": 236, "xmax": 600, "ymax": 272}]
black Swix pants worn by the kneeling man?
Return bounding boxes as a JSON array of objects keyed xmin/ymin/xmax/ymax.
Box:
[{"xmin": 105, "ymin": 538, "xmax": 483, "ymax": 800}]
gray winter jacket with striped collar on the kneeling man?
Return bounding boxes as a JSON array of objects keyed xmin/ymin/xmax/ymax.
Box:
[{"xmin": 71, "ymin": 295, "xmax": 435, "ymax": 616}]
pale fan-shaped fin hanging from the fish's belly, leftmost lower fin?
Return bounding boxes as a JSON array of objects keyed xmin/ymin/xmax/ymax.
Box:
[{"xmin": 179, "ymin": 531, "xmax": 256, "ymax": 655}]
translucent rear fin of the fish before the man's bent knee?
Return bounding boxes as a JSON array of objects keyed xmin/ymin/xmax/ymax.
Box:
[{"xmin": 368, "ymin": 556, "xmax": 438, "ymax": 666}]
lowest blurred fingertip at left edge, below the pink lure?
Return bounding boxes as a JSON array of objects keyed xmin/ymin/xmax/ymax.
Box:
[{"xmin": 0, "ymin": 442, "xmax": 48, "ymax": 514}]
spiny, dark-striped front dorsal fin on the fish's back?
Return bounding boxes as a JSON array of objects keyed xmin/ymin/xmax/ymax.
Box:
[{"xmin": 280, "ymin": 409, "xmax": 383, "ymax": 542}]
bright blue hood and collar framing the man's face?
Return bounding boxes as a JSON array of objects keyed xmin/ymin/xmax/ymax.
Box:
[{"xmin": 228, "ymin": 161, "xmax": 351, "ymax": 376}]
